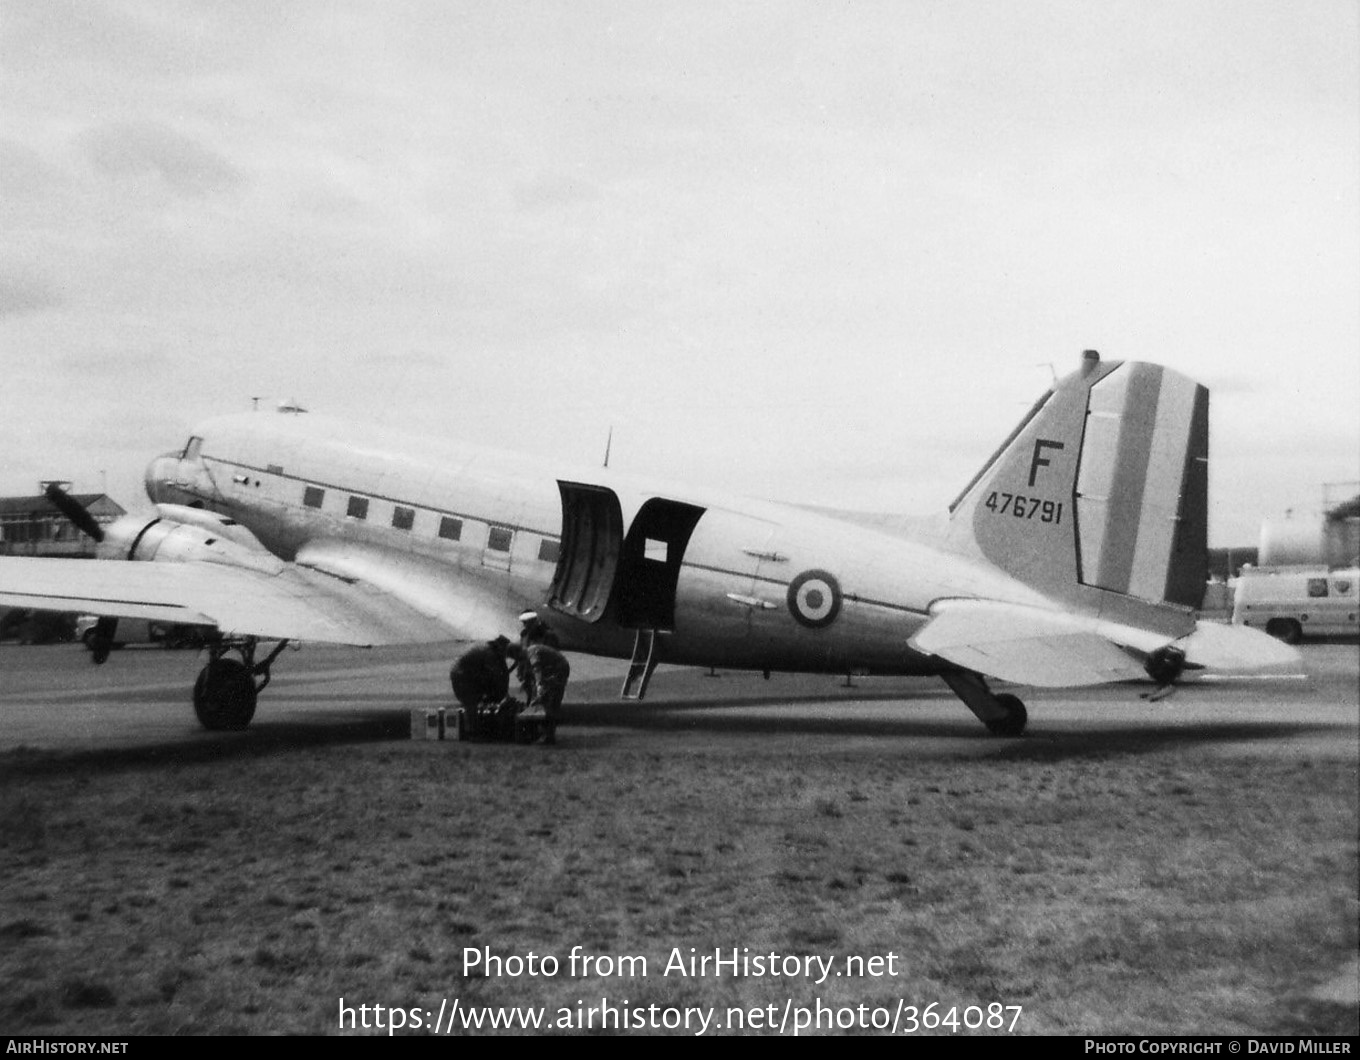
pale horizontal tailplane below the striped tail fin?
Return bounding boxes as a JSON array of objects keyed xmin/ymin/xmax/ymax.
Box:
[{"xmin": 910, "ymin": 600, "xmax": 1299, "ymax": 689}]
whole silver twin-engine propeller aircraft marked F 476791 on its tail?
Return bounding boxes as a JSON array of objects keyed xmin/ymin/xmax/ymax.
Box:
[{"xmin": 0, "ymin": 351, "xmax": 1295, "ymax": 735}]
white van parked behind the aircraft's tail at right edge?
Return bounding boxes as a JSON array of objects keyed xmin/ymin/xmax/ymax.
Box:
[{"xmin": 1232, "ymin": 567, "xmax": 1360, "ymax": 644}]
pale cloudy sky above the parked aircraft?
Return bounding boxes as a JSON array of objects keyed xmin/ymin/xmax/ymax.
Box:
[{"xmin": 0, "ymin": 0, "xmax": 1360, "ymax": 544}]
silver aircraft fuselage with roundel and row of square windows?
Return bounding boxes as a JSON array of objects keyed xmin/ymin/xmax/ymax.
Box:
[{"xmin": 147, "ymin": 414, "xmax": 1046, "ymax": 674}]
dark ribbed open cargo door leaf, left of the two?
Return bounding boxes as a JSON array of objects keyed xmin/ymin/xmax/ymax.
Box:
[{"xmin": 548, "ymin": 482, "xmax": 624, "ymax": 622}]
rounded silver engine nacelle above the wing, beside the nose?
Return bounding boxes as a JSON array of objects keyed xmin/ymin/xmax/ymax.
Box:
[{"xmin": 98, "ymin": 505, "xmax": 284, "ymax": 574}]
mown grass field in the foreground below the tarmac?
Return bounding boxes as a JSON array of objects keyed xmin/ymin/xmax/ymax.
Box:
[{"xmin": 0, "ymin": 712, "xmax": 1357, "ymax": 1034}]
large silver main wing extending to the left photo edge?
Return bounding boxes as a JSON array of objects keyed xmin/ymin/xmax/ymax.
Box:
[{"xmin": 0, "ymin": 558, "xmax": 456, "ymax": 645}]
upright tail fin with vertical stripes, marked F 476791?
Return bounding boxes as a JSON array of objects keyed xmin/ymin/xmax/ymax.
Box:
[{"xmin": 949, "ymin": 350, "xmax": 1209, "ymax": 626}]
